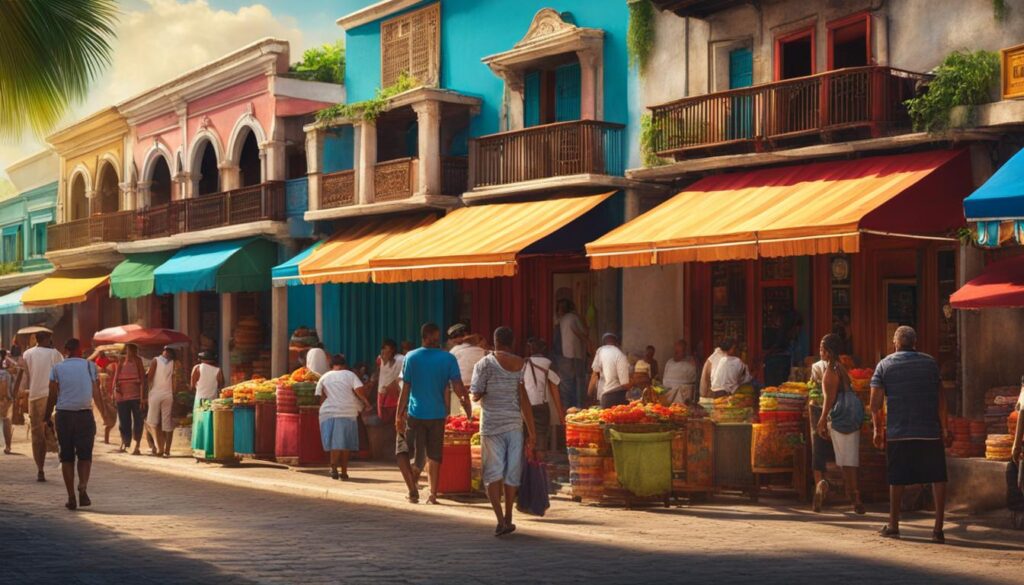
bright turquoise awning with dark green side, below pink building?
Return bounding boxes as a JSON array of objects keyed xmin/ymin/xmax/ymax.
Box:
[{"xmin": 154, "ymin": 238, "xmax": 278, "ymax": 294}]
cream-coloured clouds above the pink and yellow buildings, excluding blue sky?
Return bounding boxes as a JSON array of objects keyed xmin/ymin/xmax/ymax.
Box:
[{"xmin": 0, "ymin": 0, "xmax": 305, "ymax": 176}]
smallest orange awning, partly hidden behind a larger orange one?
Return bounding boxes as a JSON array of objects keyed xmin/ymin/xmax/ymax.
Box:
[{"xmin": 299, "ymin": 215, "xmax": 435, "ymax": 285}]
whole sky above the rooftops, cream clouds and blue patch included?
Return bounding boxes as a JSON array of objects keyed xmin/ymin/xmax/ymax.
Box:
[{"xmin": 0, "ymin": 0, "xmax": 360, "ymax": 186}]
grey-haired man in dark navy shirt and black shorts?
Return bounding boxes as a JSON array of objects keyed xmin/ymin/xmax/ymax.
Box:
[{"xmin": 871, "ymin": 326, "xmax": 952, "ymax": 544}]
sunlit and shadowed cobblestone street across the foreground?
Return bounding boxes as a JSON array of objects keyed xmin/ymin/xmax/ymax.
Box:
[{"xmin": 0, "ymin": 429, "xmax": 1024, "ymax": 585}]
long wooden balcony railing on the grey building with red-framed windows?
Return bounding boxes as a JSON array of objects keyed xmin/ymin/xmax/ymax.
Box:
[{"xmin": 650, "ymin": 66, "xmax": 930, "ymax": 158}]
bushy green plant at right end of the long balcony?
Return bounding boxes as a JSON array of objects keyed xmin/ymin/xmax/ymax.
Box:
[{"xmin": 906, "ymin": 50, "xmax": 999, "ymax": 132}]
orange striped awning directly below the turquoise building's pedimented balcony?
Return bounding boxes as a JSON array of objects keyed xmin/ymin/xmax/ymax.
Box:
[{"xmin": 370, "ymin": 193, "xmax": 612, "ymax": 283}]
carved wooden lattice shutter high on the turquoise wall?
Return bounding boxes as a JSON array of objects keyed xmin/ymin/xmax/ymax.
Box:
[{"xmin": 381, "ymin": 3, "xmax": 441, "ymax": 87}]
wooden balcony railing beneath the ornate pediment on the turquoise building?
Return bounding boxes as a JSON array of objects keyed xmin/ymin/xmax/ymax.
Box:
[{"xmin": 470, "ymin": 120, "xmax": 625, "ymax": 186}]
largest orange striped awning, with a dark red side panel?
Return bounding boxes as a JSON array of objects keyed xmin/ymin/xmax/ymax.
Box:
[{"xmin": 587, "ymin": 151, "xmax": 971, "ymax": 268}]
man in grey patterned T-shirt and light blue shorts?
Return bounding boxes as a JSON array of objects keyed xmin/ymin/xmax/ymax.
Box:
[{"xmin": 470, "ymin": 327, "xmax": 537, "ymax": 536}]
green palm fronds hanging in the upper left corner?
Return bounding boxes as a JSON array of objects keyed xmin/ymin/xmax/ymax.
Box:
[{"xmin": 0, "ymin": 0, "xmax": 118, "ymax": 138}]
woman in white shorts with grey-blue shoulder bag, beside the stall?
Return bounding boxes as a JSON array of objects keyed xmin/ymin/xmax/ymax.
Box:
[{"xmin": 814, "ymin": 333, "xmax": 864, "ymax": 514}]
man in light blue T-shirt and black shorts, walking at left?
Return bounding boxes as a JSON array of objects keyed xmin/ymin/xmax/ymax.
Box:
[{"xmin": 46, "ymin": 337, "xmax": 99, "ymax": 510}]
